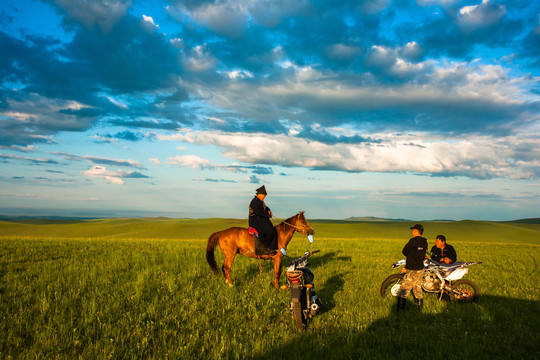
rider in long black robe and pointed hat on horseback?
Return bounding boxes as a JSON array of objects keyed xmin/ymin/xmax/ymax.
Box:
[{"xmin": 249, "ymin": 185, "xmax": 277, "ymax": 250}]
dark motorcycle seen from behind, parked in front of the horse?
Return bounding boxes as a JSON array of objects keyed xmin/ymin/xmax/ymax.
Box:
[{"xmin": 281, "ymin": 250, "xmax": 322, "ymax": 329}]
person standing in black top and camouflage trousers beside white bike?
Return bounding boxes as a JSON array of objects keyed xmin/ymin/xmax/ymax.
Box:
[{"xmin": 397, "ymin": 224, "xmax": 427, "ymax": 312}]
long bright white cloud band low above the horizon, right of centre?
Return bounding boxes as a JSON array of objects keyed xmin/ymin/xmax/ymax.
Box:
[{"xmin": 154, "ymin": 131, "xmax": 540, "ymax": 179}]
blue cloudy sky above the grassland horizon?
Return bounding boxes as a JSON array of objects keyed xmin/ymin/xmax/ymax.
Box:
[{"xmin": 0, "ymin": 0, "xmax": 540, "ymax": 221}]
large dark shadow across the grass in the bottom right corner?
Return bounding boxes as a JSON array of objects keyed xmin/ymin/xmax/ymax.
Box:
[{"xmin": 255, "ymin": 295, "xmax": 540, "ymax": 359}]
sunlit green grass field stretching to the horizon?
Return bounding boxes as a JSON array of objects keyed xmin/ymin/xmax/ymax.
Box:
[{"xmin": 0, "ymin": 218, "xmax": 540, "ymax": 359}]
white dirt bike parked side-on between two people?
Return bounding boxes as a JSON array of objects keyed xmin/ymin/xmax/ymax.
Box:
[{"xmin": 381, "ymin": 259, "xmax": 482, "ymax": 302}]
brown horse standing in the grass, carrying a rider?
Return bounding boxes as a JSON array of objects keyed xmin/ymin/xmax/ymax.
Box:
[{"xmin": 206, "ymin": 211, "xmax": 315, "ymax": 288}]
